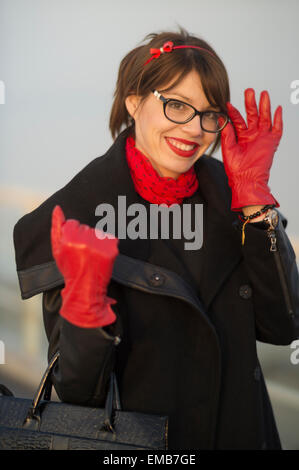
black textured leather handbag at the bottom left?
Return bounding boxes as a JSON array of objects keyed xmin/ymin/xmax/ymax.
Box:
[{"xmin": 0, "ymin": 352, "xmax": 168, "ymax": 450}]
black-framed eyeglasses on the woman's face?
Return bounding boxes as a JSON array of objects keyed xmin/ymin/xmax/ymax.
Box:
[{"xmin": 152, "ymin": 90, "xmax": 228, "ymax": 133}]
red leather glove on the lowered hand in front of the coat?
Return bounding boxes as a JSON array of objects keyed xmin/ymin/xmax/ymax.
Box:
[{"xmin": 51, "ymin": 206, "xmax": 118, "ymax": 328}]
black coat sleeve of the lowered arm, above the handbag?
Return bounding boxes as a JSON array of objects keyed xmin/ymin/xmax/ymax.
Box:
[{"xmin": 43, "ymin": 287, "xmax": 120, "ymax": 406}]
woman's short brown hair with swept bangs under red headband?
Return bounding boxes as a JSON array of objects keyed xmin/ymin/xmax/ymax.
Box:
[{"xmin": 109, "ymin": 27, "xmax": 230, "ymax": 154}]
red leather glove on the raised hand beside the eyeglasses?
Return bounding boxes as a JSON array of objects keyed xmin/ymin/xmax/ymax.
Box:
[{"xmin": 221, "ymin": 88, "xmax": 283, "ymax": 211}]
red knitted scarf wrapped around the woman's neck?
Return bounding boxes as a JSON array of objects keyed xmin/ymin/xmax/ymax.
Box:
[{"xmin": 126, "ymin": 137, "xmax": 198, "ymax": 206}]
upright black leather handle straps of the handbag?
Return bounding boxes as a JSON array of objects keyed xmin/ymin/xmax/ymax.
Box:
[{"xmin": 23, "ymin": 351, "xmax": 121, "ymax": 433}]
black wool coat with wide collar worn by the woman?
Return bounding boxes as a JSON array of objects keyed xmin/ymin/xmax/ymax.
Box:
[{"xmin": 14, "ymin": 126, "xmax": 299, "ymax": 450}]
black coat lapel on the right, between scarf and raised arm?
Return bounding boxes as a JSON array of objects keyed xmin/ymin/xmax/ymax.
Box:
[{"xmin": 195, "ymin": 155, "xmax": 242, "ymax": 309}]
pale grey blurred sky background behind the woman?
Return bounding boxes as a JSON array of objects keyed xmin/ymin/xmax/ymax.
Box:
[{"xmin": 0, "ymin": 0, "xmax": 299, "ymax": 448}]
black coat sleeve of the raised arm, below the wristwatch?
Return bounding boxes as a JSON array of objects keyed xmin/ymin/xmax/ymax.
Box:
[{"xmin": 242, "ymin": 211, "xmax": 299, "ymax": 345}]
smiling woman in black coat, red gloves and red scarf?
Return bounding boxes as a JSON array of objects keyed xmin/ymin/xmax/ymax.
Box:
[{"xmin": 14, "ymin": 30, "xmax": 299, "ymax": 449}]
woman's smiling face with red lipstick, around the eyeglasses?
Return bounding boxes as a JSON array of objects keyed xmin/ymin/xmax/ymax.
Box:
[{"xmin": 126, "ymin": 70, "xmax": 218, "ymax": 179}]
